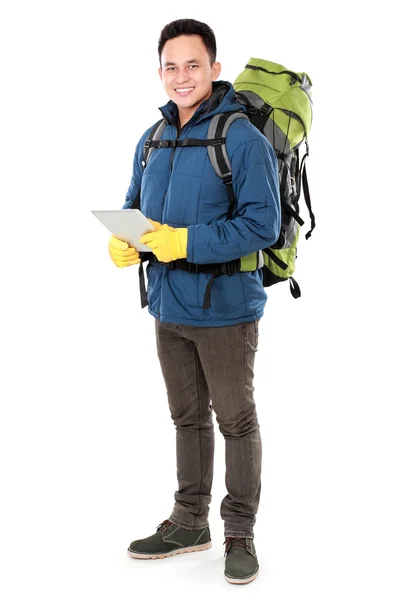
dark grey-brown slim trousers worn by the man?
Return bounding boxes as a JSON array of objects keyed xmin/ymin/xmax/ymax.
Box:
[{"xmin": 156, "ymin": 319, "xmax": 262, "ymax": 538}]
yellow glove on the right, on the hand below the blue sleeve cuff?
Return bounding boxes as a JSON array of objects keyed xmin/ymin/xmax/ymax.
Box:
[{"xmin": 140, "ymin": 225, "xmax": 188, "ymax": 262}]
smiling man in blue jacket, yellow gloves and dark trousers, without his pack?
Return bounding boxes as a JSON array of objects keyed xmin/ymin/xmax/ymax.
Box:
[{"xmin": 109, "ymin": 19, "xmax": 280, "ymax": 583}]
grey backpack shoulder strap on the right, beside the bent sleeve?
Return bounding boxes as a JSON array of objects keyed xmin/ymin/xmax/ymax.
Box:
[{"xmin": 207, "ymin": 112, "xmax": 249, "ymax": 220}]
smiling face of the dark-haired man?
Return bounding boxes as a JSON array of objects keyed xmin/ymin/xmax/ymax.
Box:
[{"xmin": 158, "ymin": 35, "xmax": 221, "ymax": 122}]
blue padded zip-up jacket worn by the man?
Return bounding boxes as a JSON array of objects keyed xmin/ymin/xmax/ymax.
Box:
[{"xmin": 123, "ymin": 81, "xmax": 281, "ymax": 327}]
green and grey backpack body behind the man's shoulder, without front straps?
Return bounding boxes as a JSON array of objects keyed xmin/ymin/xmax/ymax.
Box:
[{"xmin": 233, "ymin": 58, "xmax": 315, "ymax": 298}]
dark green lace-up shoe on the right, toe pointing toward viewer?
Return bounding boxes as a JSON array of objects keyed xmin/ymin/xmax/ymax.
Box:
[{"xmin": 224, "ymin": 537, "xmax": 258, "ymax": 583}]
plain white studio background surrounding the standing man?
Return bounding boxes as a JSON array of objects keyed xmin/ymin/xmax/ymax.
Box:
[{"xmin": 0, "ymin": 0, "xmax": 400, "ymax": 600}]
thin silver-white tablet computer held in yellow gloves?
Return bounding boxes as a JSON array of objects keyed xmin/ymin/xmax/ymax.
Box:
[{"xmin": 92, "ymin": 208, "xmax": 155, "ymax": 252}]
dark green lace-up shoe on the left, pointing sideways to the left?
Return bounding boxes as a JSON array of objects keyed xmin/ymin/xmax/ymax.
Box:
[{"xmin": 128, "ymin": 520, "xmax": 211, "ymax": 558}]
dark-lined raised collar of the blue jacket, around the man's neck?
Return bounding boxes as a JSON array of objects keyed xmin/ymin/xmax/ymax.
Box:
[{"xmin": 159, "ymin": 81, "xmax": 245, "ymax": 126}]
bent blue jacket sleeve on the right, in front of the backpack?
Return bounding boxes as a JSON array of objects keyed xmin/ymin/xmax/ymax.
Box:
[{"xmin": 187, "ymin": 137, "xmax": 281, "ymax": 264}]
